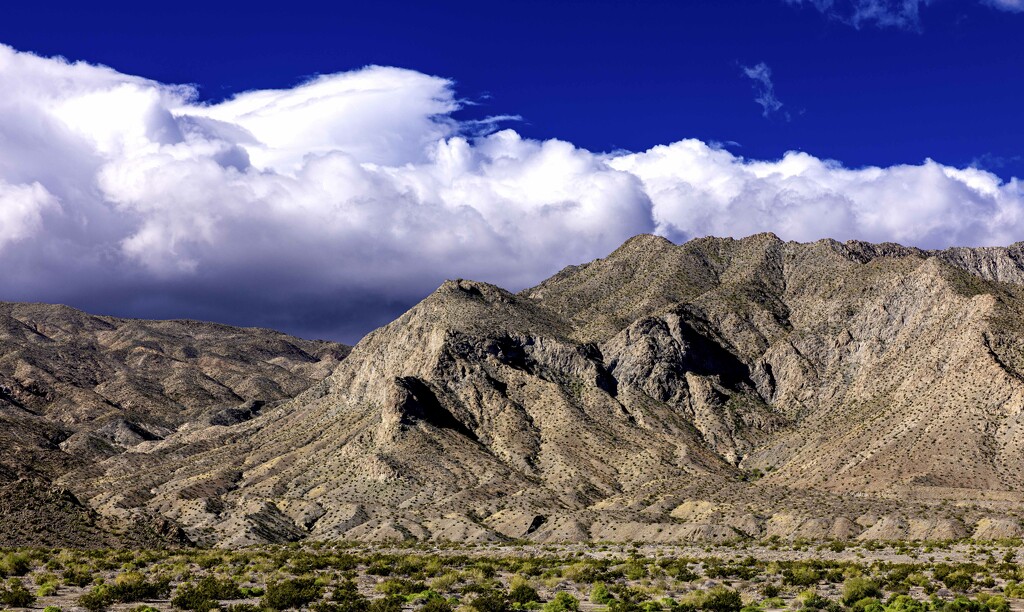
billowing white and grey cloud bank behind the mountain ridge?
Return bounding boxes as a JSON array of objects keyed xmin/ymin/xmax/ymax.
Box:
[{"xmin": 0, "ymin": 46, "xmax": 1024, "ymax": 341}]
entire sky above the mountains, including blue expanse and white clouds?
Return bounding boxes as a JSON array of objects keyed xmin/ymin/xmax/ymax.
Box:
[{"xmin": 0, "ymin": 0, "xmax": 1024, "ymax": 342}]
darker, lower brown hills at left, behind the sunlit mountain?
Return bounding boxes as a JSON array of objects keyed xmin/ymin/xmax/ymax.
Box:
[{"xmin": 0, "ymin": 303, "xmax": 349, "ymax": 545}]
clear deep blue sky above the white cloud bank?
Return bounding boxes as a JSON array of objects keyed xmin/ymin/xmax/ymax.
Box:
[{"xmin": 0, "ymin": 0, "xmax": 1024, "ymax": 177}]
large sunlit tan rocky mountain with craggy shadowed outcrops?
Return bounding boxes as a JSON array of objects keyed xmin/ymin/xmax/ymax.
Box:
[{"xmin": 56, "ymin": 234, "xmax": 1024, "ymax": 545}]
